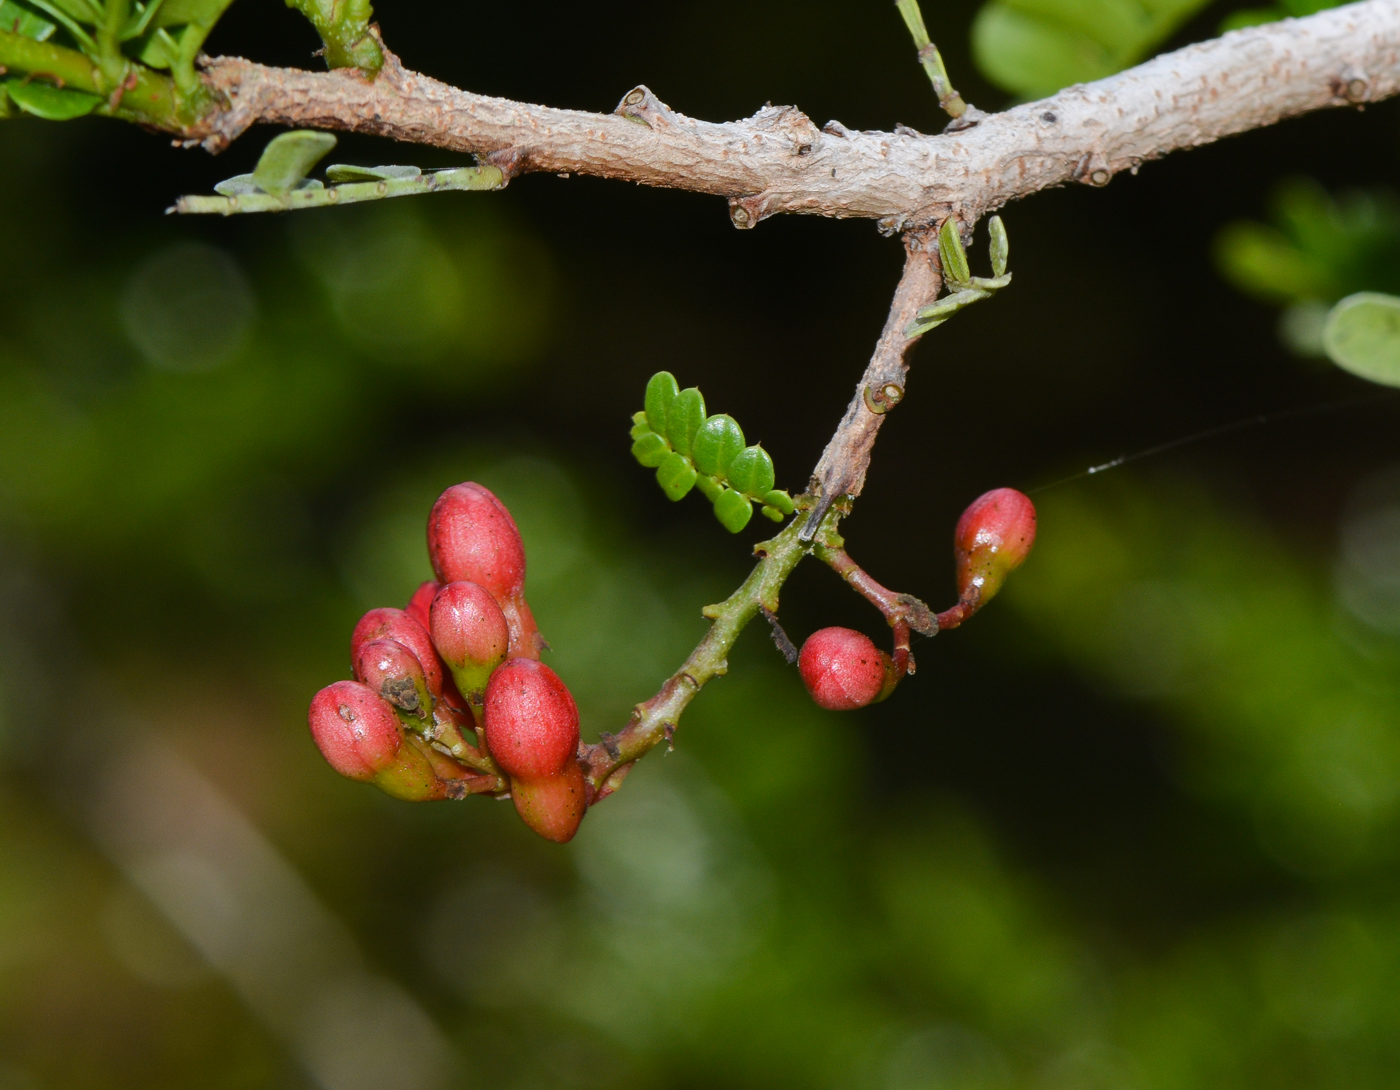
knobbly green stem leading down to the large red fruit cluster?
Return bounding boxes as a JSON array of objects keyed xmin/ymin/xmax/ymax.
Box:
[{"xmin": 584, "ymin": 508, "xmax": 828, "ymax": 798}]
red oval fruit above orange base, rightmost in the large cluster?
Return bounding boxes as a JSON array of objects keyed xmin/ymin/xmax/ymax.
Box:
[{"xmin": 482, "ymin": 659, "xmax": 578, "ymax": 779}]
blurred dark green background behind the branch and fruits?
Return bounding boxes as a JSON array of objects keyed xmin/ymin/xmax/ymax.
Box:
[{"xmin": 0, "ymin": 0, "xmax": 1400, "ymax": 1090}]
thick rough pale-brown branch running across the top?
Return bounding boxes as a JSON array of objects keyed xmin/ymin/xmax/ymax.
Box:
[{"xmin": 195, "ymin": 0, "xmax": 1400, "ymax": 229}]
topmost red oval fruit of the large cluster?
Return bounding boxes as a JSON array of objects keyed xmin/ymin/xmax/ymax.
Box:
[{"xmin": 428, "ymin": 481, "xmax": 525, "ymax": 600}]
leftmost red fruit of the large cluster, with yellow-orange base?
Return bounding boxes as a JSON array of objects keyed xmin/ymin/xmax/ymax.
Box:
[{"xmin": 307, "ymin": 681, "xmax": 447, "ymax": 802}]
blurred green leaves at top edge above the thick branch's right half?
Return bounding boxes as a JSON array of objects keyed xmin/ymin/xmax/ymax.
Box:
[{"xmin": 972, "ymin": 0, "xmax": 1334, "ymax": 99}]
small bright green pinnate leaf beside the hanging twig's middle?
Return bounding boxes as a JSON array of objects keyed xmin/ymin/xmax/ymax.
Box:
[{"xmin": 631, "ymin": 371, "xmax": 794, "ymax": 533}]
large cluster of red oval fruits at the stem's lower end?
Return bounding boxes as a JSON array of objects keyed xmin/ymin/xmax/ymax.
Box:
[{"xmin": 309, "ymin": 481, "xmax": 588, "ymax": 842}]
